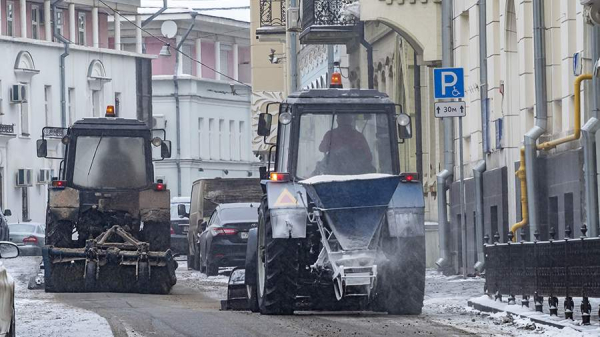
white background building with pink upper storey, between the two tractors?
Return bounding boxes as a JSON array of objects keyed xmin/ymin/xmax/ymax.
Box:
[{"xmin": 116, "ymin": 5, "xmax": 258, "ymax": 196}]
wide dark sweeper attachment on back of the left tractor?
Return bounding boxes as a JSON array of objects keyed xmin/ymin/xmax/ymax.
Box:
[{"xmin": 43, "ymin": 226, "xmax": 177, "ymax": 294}]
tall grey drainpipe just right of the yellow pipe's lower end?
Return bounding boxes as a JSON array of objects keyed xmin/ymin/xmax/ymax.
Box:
[{"xmin": 524, "ymin": 0, "xmax": 548, "ymax": 237}]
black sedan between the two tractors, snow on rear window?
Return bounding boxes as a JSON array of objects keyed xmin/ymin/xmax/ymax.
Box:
[{"xmin": 197, "ymin": 203, "xmax": 259, "ymax": 276}]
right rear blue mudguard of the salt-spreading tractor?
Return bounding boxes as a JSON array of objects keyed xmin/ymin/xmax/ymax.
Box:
[{"xmin": 386, "ymin": 182, "xmax": 425, "ymax": 238}]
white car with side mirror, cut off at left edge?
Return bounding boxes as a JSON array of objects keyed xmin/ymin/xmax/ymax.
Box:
[{"xmin": 0, "ymin": 241, "xmax": 19, "ymax": 337}]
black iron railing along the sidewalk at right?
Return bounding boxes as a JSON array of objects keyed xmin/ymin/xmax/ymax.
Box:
[{"xmin": 484, "ymin": 225, "xmax": 600, "ymax": 325}]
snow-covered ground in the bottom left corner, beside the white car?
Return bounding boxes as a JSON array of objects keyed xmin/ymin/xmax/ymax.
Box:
[{"xmin": 2, "ymin": 256, "xmax": 113, "ymax": 337}]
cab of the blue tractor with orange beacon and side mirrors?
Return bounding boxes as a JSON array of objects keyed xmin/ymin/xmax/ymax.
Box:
[{"xmin": 258, "ymin": 73, "xmax": 412, "ymax": 181}]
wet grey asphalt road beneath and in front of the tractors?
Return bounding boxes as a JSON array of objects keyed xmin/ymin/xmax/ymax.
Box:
[{"xmin": 56, "ymin": 262, "xmax": 471, "ymax": 337}]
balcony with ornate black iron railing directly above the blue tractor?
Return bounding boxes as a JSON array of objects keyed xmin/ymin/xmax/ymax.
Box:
[{"xmin": 300, "ymin": 0, "xmax": 359, "ymax": 44}]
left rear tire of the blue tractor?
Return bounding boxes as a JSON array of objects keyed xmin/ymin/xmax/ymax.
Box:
[{"xmin": 256, "ymin": 200, "xmax": 299, "ymax": 315}]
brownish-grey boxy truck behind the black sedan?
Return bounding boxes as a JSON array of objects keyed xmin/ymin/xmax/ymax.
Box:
[{"xmin": 183, "ymin": 178, "xmax": 263, "ymax": 270}]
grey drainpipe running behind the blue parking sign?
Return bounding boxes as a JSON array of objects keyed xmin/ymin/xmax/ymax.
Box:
[{"xmin": 436, "ymin": 0, "xmax": 454, "ymax": 270}]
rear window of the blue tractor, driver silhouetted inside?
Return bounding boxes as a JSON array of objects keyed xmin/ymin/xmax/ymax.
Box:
[{"xmin": 296, "ymin": 113, "xmax": 393, "ymax": 179}]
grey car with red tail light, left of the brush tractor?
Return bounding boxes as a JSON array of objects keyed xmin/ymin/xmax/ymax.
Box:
[{"xmin": 8, "ymin": 222, "xmax": 46, "ymax": 256}]
